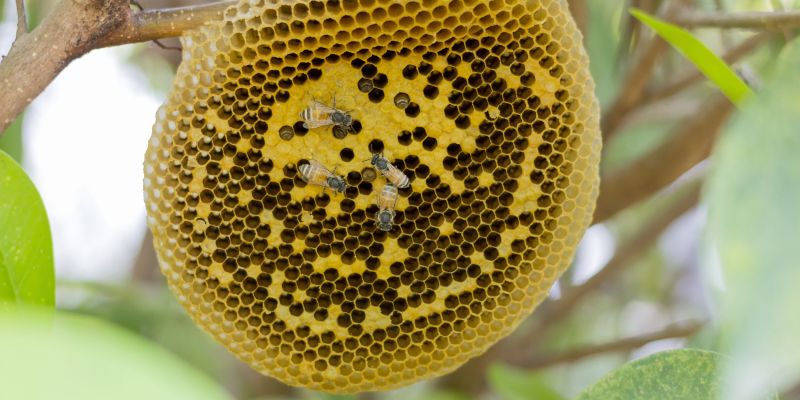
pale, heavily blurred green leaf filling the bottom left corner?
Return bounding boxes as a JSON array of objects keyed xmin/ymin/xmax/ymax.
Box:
[{"xmin": 0, "ymin": 313, "xmax": 230, "ymax": 400}]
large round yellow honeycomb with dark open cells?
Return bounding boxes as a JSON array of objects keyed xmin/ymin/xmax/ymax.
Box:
[{"xmin": 144, "ymin": 0, "xmax": 601, "ymax": 393}]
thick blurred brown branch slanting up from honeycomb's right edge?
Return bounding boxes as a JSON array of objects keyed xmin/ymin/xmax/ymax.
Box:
[{"xmin": 594, "ymin": 93, "xmax": 733, "ymax": 223}]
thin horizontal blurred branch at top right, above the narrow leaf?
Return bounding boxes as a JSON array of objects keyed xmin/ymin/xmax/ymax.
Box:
[{"xmin": 669, "ymin": 10, "xmax": 800, "ymax": 30}]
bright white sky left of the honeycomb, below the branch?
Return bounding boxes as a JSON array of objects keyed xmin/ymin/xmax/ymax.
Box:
[{"xmin": 0, "ymin": 7, "xmax": 164, "ymax": 281}]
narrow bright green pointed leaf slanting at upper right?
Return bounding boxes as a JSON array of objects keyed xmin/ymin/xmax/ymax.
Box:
[{"xmin": 630, "ymin": 9, "xmax": 752, "ymax": 105}]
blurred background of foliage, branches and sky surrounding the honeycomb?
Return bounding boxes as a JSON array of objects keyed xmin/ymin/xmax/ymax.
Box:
[{"xmin": 0, "ymin": 0, "xmax": 800, "ymax": 400}]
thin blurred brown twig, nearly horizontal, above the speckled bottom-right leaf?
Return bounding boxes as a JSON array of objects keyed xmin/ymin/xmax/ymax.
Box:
[{"xmin": 511, "ymin": 322, "xmax": 703, "ymax": 369}]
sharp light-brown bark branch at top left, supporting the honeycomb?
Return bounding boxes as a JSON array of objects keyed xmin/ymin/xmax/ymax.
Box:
[{"xmin": 0, "ymin": 0, "xmax": 235, "ymax": 135}]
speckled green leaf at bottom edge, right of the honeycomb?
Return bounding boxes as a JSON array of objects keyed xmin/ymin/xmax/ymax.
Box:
[{"xmin": 574, "ymin": 349, "xmax": 777, "ymax": 400}]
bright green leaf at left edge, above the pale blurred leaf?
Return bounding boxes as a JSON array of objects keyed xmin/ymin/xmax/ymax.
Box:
[{"xmin": 0, "ymin": 150, "xmax": 55, "ymax": 310}]
